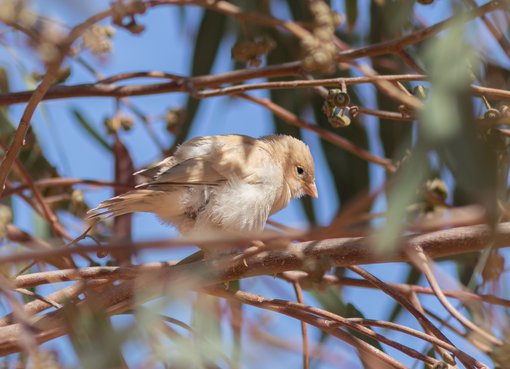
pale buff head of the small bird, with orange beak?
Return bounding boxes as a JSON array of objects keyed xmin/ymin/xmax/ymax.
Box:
[{"xmin": 264, "ymin": 135, "xmax": 319, "ymax": 199}]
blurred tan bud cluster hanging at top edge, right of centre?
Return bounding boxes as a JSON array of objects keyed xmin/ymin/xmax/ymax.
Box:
[{"xmin": 301, "ymin": 0, "xmax": 341, "ymax": 73}]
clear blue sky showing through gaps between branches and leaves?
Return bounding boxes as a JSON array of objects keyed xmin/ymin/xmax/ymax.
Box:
[{"xmin": 0, "ymin": 0, "xmax": 501, "ymax": 368}]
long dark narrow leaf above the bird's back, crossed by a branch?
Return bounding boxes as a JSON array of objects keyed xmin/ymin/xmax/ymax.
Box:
[{"xmin": 175, "ymin": 9, "xmax": 227, "ymax": 144}]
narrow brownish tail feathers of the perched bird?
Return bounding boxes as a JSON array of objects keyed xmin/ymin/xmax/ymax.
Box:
[{"xmin": 87, "ymin": 190, "xmax": 161, "ymax": 220}]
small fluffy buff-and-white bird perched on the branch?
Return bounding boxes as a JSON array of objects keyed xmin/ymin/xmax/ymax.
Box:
[{"xmin": 87, "ymin": 134, "xmax": 318, "ymax": 253}]
